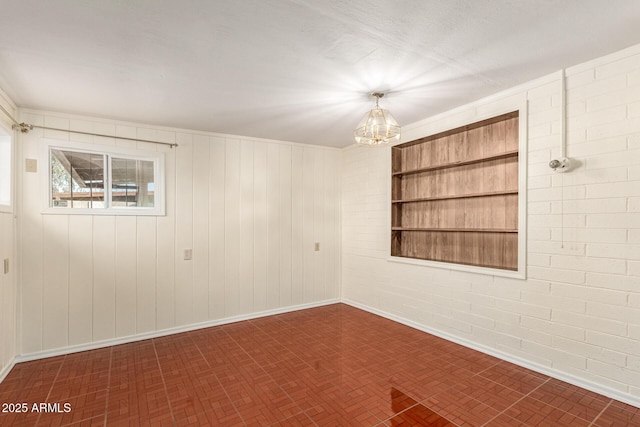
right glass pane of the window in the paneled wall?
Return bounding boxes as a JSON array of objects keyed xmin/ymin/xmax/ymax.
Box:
[{"xmin": 111, "ymin": 157, "xmax": 155, "ymax": 208}]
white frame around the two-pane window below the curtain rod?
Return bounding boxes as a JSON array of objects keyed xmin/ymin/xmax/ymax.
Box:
[{"xmin": 40, "ymin": 139, "xmax": 166, "ymax": 216}]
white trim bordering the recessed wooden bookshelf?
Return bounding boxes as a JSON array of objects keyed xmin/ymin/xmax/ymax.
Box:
[{"xmin": 386, "ymin": 99, "xmax": 528, "ymax": 280}]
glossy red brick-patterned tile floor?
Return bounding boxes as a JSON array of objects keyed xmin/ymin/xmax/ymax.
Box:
[{"xmin": 0, "ymin": 304, "xmax": 640, "ymax": 427}]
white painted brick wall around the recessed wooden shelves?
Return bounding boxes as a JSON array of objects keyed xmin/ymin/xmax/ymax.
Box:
[{"xmin": 341, "ymin": 46, "xmax": 640, "ymax": 404}]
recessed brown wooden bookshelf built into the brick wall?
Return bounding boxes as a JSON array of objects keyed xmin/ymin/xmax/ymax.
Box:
[{"xmin": 391, "ymin": 111, "xmax": 523, "ymax": 278}]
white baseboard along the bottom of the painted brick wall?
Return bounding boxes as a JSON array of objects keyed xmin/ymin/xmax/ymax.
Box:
[{"xmin": 341, "ymin": 298, "xmax": 640, "ymax": 408}]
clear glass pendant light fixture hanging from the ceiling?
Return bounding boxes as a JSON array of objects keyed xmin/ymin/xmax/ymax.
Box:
[{"xmin": 353, "ymin": 92, "xmax": 400, "ymax": 145}]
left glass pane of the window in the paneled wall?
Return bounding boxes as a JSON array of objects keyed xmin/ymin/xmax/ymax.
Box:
[{"xmin": 51, "ymin": 148, "xmax": 104, "ymax": 208}]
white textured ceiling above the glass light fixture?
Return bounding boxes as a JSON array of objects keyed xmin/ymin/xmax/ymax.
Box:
[{"xmin": 0, "ymin": 0, "xmax": 640, "ymax": 147}]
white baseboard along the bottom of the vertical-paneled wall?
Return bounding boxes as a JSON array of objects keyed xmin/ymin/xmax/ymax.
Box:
[{"xmin": 13, "ymin": 298, "xmax": 340, "ymax": 366}]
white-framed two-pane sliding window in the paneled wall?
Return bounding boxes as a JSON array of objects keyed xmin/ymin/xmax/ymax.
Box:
[{"xmin": 45, "ymin": 141, "xmax": 164, "ymax": 215}]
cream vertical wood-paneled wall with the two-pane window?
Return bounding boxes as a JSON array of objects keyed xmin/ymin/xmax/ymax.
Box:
[{"xmin": 20, "ymin": 111, "xmax": 341, "ymax": 354}]
